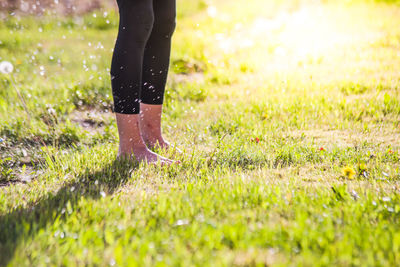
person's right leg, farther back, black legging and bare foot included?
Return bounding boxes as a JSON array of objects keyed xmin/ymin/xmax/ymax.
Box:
[{"xmin": 140, "ymin": 0, "xmax": 176, "ymax": 151}]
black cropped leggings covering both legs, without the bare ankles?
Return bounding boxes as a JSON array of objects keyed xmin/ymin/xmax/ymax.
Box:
[{"xmin": 110, "ymin": 0, "xmax": 176, "ymax": 114}]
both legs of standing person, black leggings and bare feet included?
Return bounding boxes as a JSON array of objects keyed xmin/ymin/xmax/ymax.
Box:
[{"xmin": 110, "ymin": 0, "xmax": 176, "ymax": 163}]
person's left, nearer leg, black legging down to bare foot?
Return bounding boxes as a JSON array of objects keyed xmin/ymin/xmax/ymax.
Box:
[{"xmin": 110, "ymin": 0, "xmax": 171, "ymax": 162}]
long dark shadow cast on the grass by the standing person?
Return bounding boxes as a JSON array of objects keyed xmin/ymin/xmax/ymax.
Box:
[{"xmin": 0, "ymin": 160, "xmax": 138, "ymax": 266}]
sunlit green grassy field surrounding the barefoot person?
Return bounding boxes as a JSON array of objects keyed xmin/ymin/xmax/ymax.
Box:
[{"xmin": 0, "ymin": 0, "xmax": 400, "ymax": 266}]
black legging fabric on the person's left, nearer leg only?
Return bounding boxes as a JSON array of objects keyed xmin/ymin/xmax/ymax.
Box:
[{"xmin": 110, "ymin": 0, "xmax": 154, "ymax": 114}]
